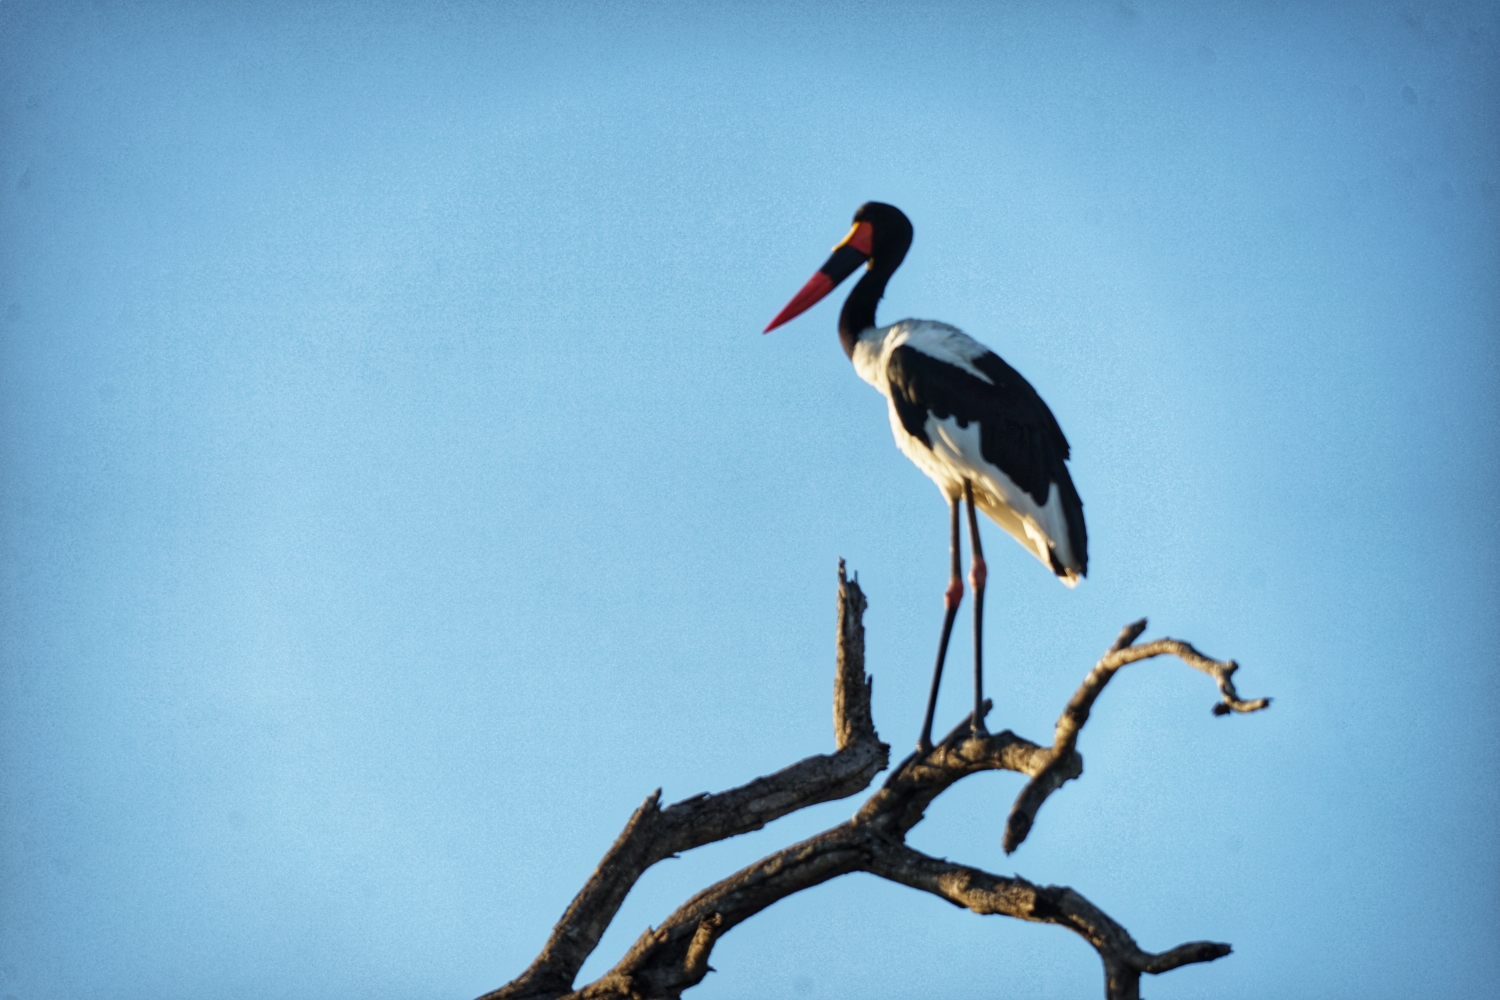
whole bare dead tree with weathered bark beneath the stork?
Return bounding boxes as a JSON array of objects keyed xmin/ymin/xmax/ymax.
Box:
[{"xmin": 480, "ymin": 561, "xmax": 1271, "ymax": 1000}]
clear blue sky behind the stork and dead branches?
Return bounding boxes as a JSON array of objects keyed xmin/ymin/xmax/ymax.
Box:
[{"xmin": 0, "ymin": 1, "xmax": 1500, "ymax": 1000}]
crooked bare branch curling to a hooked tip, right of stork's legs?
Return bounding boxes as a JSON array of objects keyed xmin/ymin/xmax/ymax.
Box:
[{"xmin": 1001, "ymin": 618, "xmax": 1271, "ymax": 855}]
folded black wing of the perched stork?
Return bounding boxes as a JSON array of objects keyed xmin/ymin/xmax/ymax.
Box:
[{"xmin": 885, "ymin": 345, "xmax": 1088, "ymax": 567}]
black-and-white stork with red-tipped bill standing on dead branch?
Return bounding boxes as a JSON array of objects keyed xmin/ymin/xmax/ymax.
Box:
[{"xmin": 764, "ymin": 201, "xmax": 1089, "ymax": 754}]
